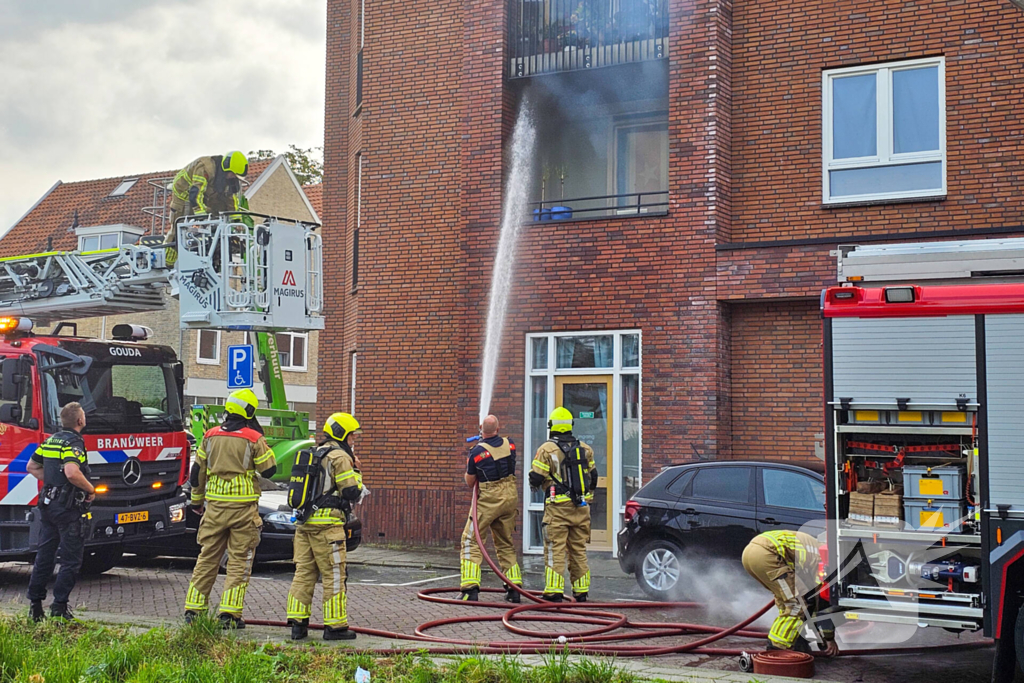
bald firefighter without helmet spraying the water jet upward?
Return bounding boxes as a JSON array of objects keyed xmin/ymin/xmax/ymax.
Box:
[{"xmin": 459, "ymin": 415, "xmax": 522, "ymax": 602}]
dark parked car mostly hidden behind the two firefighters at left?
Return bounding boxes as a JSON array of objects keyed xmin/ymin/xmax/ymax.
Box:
[{"xmin": 124, "ymin": 479, "xmax": 295, "ymax": 562}]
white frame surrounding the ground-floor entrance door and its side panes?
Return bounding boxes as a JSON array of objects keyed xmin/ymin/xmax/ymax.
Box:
[{"xmin": 522, "ymin": 330, "xmax": 643, "ymax": 555}]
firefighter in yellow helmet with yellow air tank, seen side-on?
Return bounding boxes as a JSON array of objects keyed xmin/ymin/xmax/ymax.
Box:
[{"xmin": 288, "ymin": 413, "xmax": 364, "ymax": 640}]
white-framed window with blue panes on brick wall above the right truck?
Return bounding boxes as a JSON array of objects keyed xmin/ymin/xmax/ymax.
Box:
[{"xmin": 821, "ymin": 57, "xmax": 946, "ymax": 204}]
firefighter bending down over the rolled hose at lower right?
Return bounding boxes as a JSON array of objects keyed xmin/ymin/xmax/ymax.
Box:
[{"xmin": 743, "ymin": 529, "xmax": 839, "ymax": 656}]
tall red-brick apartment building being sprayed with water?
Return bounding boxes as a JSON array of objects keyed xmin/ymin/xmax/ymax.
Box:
[{"xmin": 319, "ymin": 0, "xmax": 1024, "ymax": 551}]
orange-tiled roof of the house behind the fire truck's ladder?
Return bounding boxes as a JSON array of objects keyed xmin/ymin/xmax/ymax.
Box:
[{"xmin": 0, "ymin": 159, "xmax": 273, "ymax": 257}]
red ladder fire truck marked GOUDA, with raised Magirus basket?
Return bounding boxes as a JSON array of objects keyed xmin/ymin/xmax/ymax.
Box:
[{"xmin": 0, "ymin": 213, "xmax": 324, "ymax": 572}]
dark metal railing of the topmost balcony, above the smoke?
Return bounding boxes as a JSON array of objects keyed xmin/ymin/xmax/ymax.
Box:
[{"xmin": 509, "ymin": 0, "xmax": 669, "ymax": 78}]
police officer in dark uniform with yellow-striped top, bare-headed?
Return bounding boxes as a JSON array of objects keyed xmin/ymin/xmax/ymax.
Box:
[{"xmin": 27, "ymin": 403, "xmax": 96, "ymax": 622}]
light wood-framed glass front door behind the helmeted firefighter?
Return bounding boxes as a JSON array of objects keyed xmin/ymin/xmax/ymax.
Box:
[{"xmin": 555, "ymin": 375, "xmax": 614, "ymax": 550}]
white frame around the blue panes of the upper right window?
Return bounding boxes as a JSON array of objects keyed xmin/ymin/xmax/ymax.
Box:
[{"xmin": 821, "ymin": 56, "xmax": 946, "ymax": 205}]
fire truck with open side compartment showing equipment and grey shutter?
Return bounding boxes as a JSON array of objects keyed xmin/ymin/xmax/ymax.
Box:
[{"xmin": 821, "ymin": 239, "xmax": 1024, "ymax": 680}]
